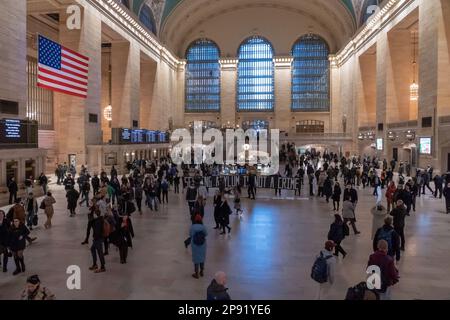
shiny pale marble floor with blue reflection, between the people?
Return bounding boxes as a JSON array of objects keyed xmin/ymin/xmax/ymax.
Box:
[{"xmin": 0, "ymin": 178, "xmax": 450, "ymax": 300}]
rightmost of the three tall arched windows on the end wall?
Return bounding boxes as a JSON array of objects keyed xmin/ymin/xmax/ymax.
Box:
[{"xmin": 292, "ymin": 35, "xmax": 330, "ymax": 111}]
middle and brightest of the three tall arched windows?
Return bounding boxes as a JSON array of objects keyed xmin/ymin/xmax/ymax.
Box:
[{"xmin": 237, "ymin": 37, "xmax": 275, "ymax": 111}]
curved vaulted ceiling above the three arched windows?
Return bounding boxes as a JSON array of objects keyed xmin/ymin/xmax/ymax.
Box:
[{"xmin": 132, "ymin": 0, "xmax": 382, "ymax": 56}]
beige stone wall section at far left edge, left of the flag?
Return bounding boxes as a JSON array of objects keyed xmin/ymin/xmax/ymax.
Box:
[{"xmin": 0, "ymin": 1, "xmax": 27, "ymax": 118}]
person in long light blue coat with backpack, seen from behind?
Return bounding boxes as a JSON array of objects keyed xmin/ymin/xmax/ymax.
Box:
[{"xmin": 189, "ymin": 215, "xmax": 208, "ymax": 279}]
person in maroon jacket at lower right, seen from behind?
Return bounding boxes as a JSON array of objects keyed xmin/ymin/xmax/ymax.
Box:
[{"xmin": 367, "ymin": 240, "xmax": 400, "ymax": 300}]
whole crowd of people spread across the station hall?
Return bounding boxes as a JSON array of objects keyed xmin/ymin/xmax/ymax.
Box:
[{"xmin": 0, "ymin": 144, "xmax": 450, "ymax": 300}]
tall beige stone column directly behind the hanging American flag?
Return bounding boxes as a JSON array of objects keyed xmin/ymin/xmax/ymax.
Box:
[{"xmin": 55, "ymin": 3, "xmax": 102, "ymax": 167}]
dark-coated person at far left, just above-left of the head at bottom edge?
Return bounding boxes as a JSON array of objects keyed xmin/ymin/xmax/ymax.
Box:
[{"xmin": 9, "ymin": 219, "xmax": 30, "ymax": 275}]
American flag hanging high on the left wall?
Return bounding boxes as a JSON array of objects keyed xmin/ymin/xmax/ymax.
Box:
[{"xmin": 37, "ymin": 35, "xmax": 89, "ymax": 98}]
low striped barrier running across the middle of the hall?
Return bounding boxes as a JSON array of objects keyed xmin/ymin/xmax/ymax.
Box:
[{"xmin": 183, "ymin": 176, "xmax": 300, "ymax": 190}]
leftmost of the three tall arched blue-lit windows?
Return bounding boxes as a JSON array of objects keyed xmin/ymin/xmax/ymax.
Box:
[{"xmin": 185, "ymin": 39, "xmax": 220, "ymax": 112}]
